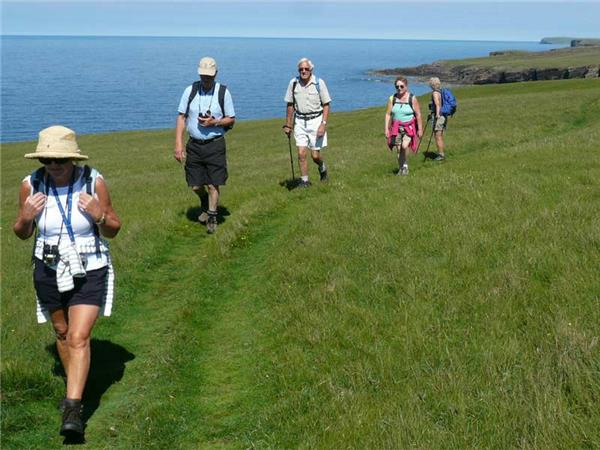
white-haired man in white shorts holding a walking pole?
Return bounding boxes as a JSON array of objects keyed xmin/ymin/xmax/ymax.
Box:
[{"xmin": 283, "ymin": 58, "xmax": 331, "ymax": 187}]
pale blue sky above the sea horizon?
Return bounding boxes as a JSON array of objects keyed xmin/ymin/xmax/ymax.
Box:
[{"xmin": 2, "ymin": 0, "xmax": 600, "ymax": 41}]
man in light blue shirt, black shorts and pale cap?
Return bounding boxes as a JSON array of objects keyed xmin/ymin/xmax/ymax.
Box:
[{"xmin": 175, "ymin": 57, "xmax": 235, "ymax": 234}]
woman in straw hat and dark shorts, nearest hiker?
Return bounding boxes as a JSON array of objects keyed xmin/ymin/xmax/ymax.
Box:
[{"xmin": 14, "ymin": 126, "xmax": 121, "ymax": 437}]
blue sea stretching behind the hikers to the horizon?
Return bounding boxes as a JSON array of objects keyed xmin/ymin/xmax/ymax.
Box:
[{"xmin": 0, "ymin": 36, "xmax": 558, "ymax": 143}]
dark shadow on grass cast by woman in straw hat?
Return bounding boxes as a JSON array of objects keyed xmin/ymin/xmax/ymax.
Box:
[{"xmin": 46, "ymin": 339, "xmax": 135, "ymax": 444}]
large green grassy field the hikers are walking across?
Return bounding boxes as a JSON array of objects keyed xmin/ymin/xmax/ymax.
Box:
[{"xmin": 1, "ymin": 80, "xmax": 600, "ymax": 449}]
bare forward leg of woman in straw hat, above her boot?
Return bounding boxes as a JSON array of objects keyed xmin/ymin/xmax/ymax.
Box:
[{"xmin": 67, "ymin": 305, "xmax": 100, "ymax": 400}]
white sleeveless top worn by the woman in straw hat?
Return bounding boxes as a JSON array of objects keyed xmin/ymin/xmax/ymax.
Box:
[{"xmin": 24, "ymin": 168, "xmax": 108, "ymax": 270}]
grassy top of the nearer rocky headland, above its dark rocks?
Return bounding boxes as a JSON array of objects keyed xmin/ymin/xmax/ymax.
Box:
[{"xmin": 440, "ymin": 46, "xmax": 600, "ymax": 70}]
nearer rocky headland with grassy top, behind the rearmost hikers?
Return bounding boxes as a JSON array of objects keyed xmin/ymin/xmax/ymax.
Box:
[{"xmin": 373, "ymin": 46, "xmax": 600, "ymax": 84}]
